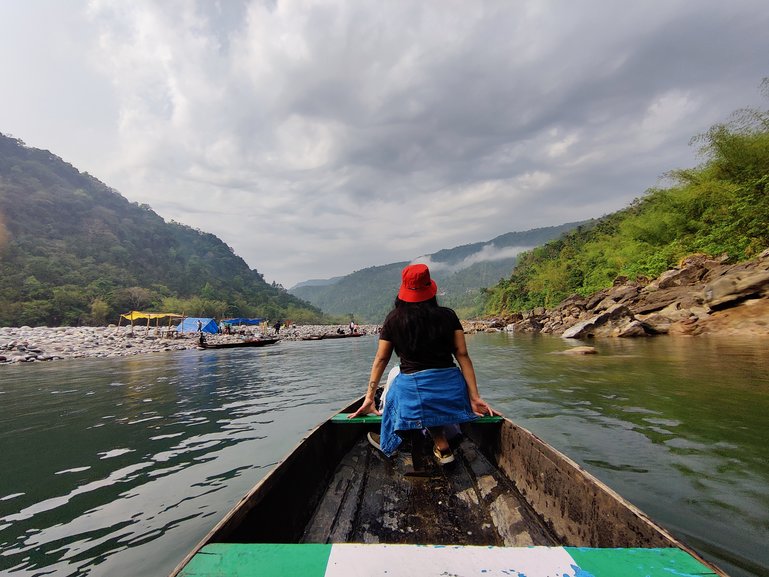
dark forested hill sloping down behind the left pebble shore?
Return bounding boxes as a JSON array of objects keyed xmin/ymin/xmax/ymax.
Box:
[{"xmin": 0, "ymin": 134, "xmax": 322, "ymax": 326}]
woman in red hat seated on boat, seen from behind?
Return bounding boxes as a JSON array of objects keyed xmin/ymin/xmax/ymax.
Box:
[{"xmin": 350, "ymin": 264, "xmax": 499, "ymax": 464}]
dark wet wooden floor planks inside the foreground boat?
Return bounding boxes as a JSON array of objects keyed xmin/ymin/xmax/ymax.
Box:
[{"xmin": 303, "ymin": 434, "xmax": 556, "ymax": 545}]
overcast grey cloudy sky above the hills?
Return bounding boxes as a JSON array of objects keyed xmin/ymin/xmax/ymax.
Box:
[{"xmin": 0, "ymin": 0, "xmax": 769, "ymax": 288}]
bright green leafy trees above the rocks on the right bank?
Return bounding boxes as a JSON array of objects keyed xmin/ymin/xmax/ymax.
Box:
[{"xmin": 485, "ymin": 86, "xmax": 769, "ymax": 315}]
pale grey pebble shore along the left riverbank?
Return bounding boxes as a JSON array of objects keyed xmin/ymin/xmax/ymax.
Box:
[{"xmin": 0, "ymin": 325, "xmax": 378, "ymax": 364}]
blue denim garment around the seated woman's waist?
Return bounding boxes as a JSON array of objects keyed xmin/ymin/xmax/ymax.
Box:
[{"xmin": 380, "ymin": 367, "xmax": 477, "ymax": 456}]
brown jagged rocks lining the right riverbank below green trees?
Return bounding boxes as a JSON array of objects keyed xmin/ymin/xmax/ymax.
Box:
[{"xmin": 505, "ymin": 250, "xmax": 769, "ymax": 339}]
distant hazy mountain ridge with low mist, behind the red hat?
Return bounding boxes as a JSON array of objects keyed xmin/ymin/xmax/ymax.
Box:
[{"xmin": 289, "ymin": 222, "xmax": 585, "ymax": 323}]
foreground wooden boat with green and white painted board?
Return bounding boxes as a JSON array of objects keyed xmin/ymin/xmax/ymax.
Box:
[{"xmin": 172, "ymin": 400, "xmax": 726, "ymax": 577}]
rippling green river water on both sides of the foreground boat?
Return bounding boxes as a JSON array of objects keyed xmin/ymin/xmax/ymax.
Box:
[{"xmin": 0, "ymin": 333, "xmax": 769, "ymax": 577}]
